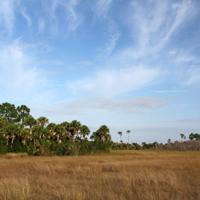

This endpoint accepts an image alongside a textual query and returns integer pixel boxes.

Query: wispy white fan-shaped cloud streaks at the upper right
[127,0,194,58]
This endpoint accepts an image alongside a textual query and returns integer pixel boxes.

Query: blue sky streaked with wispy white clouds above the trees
[0,0,200,142]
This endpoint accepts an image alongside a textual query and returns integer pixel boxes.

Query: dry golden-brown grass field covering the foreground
[0,151,200,200]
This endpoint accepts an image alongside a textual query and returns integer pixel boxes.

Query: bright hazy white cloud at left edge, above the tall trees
[0,41,52,104]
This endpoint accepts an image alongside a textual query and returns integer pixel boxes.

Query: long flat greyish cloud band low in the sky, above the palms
[47,97,167,116]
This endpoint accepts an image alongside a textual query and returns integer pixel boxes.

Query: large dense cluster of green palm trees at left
[0,103,112,155]
